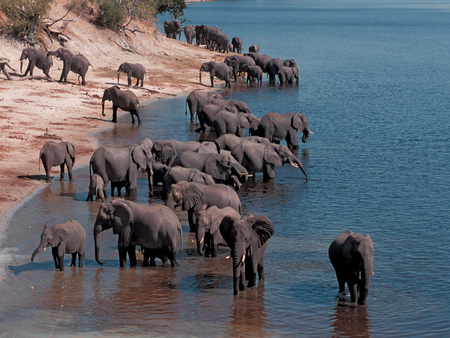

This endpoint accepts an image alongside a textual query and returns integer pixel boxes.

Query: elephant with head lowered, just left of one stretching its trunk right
[172,151,248,190]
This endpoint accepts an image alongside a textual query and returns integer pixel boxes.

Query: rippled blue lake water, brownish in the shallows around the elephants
[0,0,450,336]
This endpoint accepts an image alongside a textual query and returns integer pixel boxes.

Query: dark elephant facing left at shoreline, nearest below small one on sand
[102,86,141,124]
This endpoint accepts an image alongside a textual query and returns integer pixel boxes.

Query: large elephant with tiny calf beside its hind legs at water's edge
[89,138,153,197]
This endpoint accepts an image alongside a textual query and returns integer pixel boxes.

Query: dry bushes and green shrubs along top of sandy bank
[0,0,186,46]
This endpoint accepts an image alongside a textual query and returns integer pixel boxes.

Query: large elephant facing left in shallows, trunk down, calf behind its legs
[94,199,182,268]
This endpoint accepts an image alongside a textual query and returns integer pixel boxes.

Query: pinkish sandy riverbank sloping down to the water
[0,1,224,225]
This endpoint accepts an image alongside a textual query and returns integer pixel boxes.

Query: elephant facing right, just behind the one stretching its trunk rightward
[257,112,313,149]
